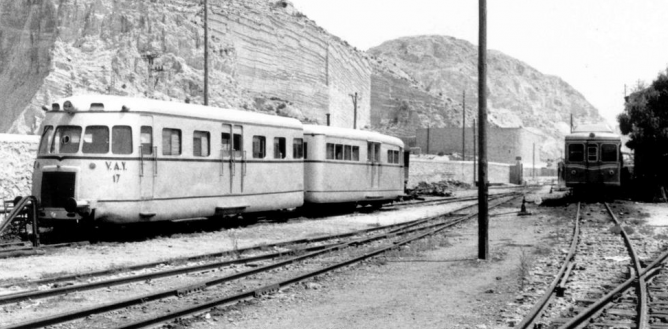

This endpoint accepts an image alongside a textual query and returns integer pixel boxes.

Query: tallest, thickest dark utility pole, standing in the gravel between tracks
[478,0,489,259]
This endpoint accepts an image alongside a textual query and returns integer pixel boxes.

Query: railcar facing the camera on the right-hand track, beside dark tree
[563,125,623,189]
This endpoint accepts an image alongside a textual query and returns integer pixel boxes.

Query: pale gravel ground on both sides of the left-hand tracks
[0,188,563,328]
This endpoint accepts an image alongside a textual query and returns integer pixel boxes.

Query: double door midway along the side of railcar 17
[221,124,247,194]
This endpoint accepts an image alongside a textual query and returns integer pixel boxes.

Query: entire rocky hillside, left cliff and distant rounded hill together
[0,0,600,158]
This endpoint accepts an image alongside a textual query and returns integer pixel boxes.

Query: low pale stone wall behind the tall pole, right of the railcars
[408,155,512,188]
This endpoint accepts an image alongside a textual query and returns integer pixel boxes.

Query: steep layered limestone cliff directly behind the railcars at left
[0,0,371,134]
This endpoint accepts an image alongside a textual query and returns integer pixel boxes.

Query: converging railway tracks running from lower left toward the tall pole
[0,191,528,328]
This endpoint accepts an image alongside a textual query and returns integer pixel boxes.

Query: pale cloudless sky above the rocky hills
[291,0,668,125]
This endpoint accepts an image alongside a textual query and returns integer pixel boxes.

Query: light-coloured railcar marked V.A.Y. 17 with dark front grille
[33,95,304,223]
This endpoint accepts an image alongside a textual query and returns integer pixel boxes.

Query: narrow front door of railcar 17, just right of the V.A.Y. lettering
[139,115,158,212]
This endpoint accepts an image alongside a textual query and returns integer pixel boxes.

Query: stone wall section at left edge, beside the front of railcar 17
[0,134,39,200]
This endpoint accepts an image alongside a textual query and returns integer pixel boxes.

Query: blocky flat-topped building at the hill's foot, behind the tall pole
[416,127,543,165]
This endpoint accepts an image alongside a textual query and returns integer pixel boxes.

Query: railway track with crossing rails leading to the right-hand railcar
[517,203,668,329]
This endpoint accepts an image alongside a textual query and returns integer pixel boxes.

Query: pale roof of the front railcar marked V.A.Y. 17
[52,95,302,129]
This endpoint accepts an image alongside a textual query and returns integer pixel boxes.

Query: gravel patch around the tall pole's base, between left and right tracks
[179,190,548,328]
